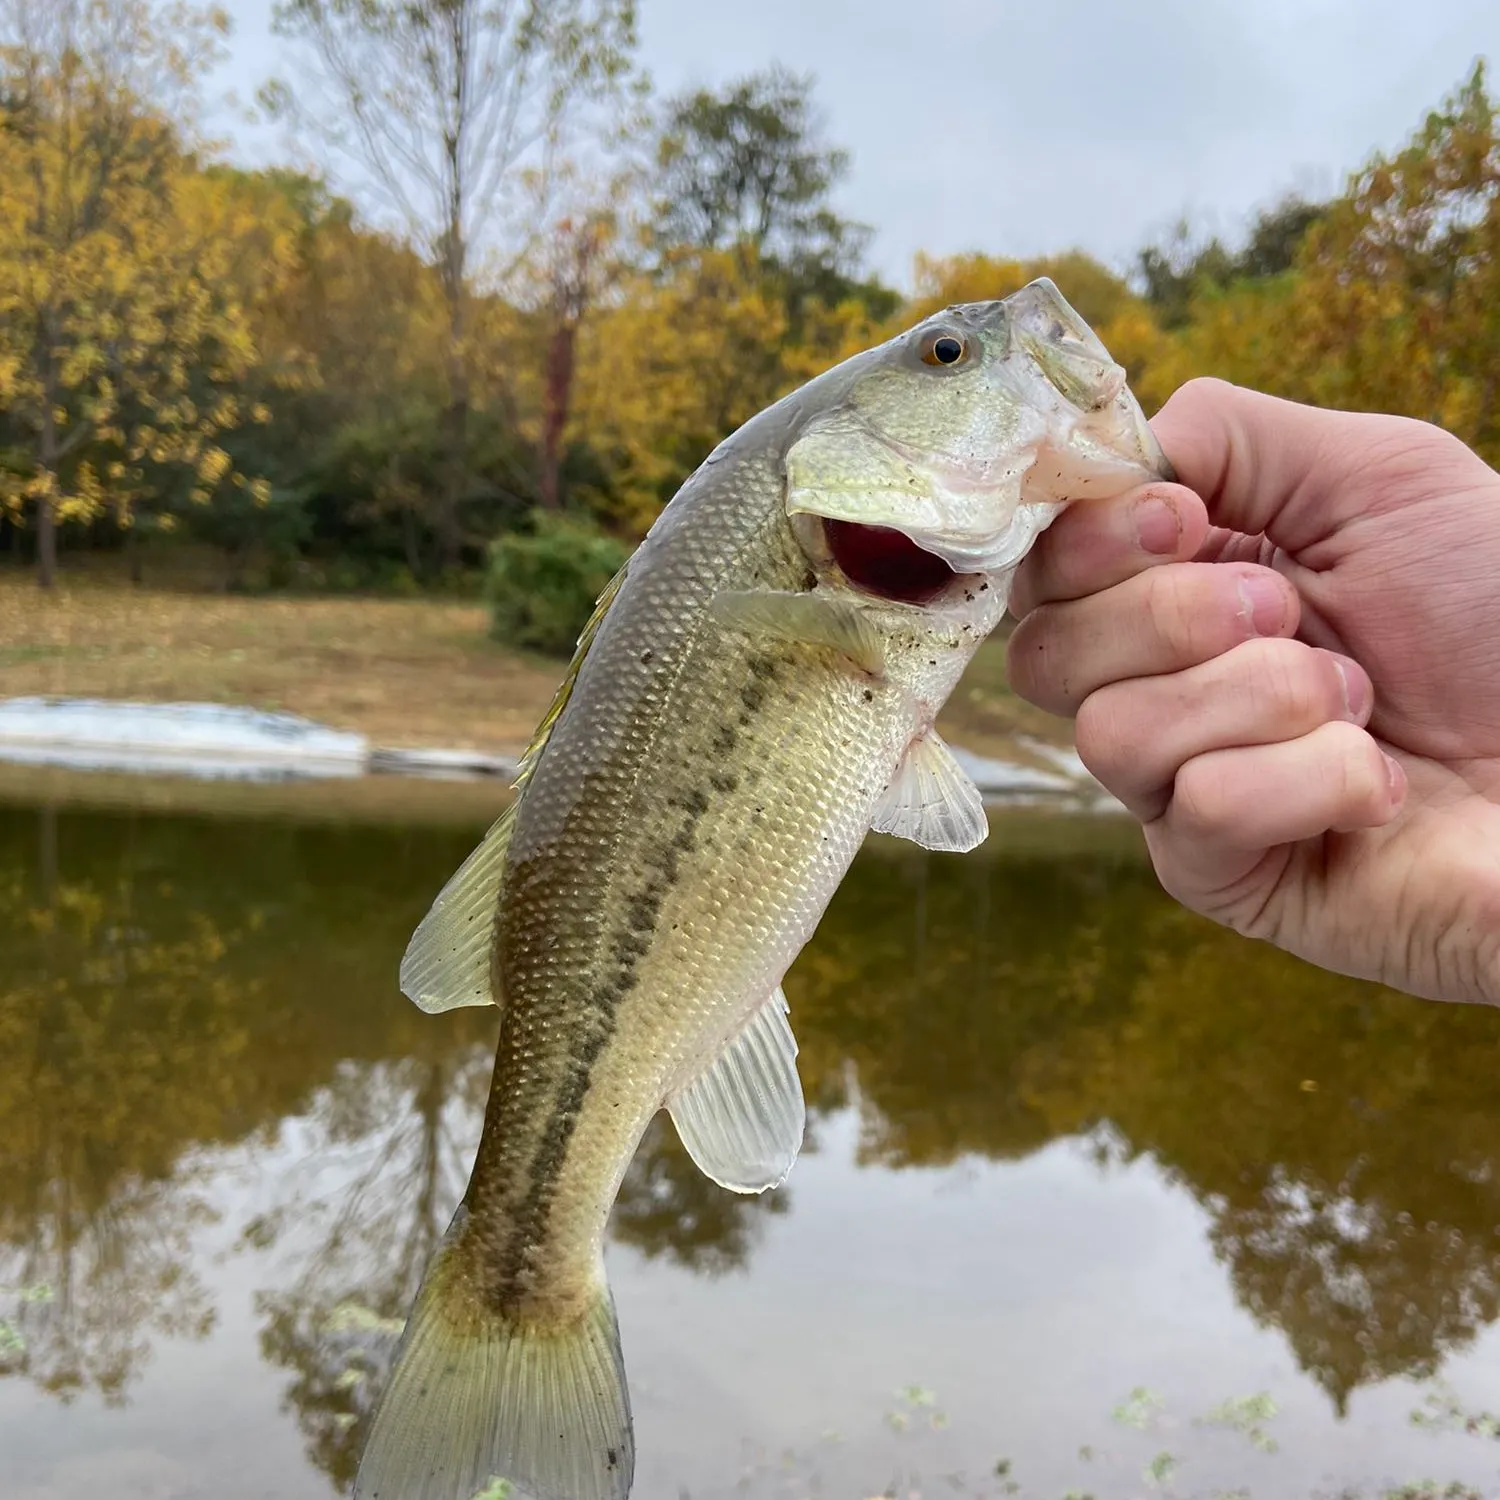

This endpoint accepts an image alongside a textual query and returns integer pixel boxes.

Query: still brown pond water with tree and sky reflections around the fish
[0,783,1500,1500]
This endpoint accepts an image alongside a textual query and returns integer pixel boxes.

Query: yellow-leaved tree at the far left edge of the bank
[0,0,289,587]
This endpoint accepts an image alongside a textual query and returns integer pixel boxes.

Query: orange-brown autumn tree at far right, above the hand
[1176,66,1500,462]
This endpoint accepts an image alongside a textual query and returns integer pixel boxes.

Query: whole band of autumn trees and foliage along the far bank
[11,19,1500,603]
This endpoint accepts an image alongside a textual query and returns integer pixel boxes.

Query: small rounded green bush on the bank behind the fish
[485,516,630,657]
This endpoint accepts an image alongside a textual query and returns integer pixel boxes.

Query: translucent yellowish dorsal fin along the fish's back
[401,563,630,1013]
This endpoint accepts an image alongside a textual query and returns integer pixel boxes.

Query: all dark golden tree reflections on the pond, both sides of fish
[0,809,1500,1484]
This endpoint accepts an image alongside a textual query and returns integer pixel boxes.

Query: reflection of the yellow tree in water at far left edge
[0,810,249,1406]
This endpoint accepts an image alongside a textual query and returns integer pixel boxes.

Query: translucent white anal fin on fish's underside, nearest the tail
[668,986,807,1193]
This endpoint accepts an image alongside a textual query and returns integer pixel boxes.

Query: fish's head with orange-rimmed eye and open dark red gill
[786,279,1170,602]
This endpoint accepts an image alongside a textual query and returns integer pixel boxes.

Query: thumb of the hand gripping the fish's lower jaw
[1151,380,1421,552]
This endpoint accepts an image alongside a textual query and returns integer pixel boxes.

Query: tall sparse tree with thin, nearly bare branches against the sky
[276,0,635,566]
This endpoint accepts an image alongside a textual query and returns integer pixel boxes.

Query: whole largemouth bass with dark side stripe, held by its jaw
[354,279,1170,1500]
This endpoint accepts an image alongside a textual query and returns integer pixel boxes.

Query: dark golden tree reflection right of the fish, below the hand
[788,855,1500,1412]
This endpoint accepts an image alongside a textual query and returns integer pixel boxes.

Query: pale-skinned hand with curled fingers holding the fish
[1010,380,1500,1004]
